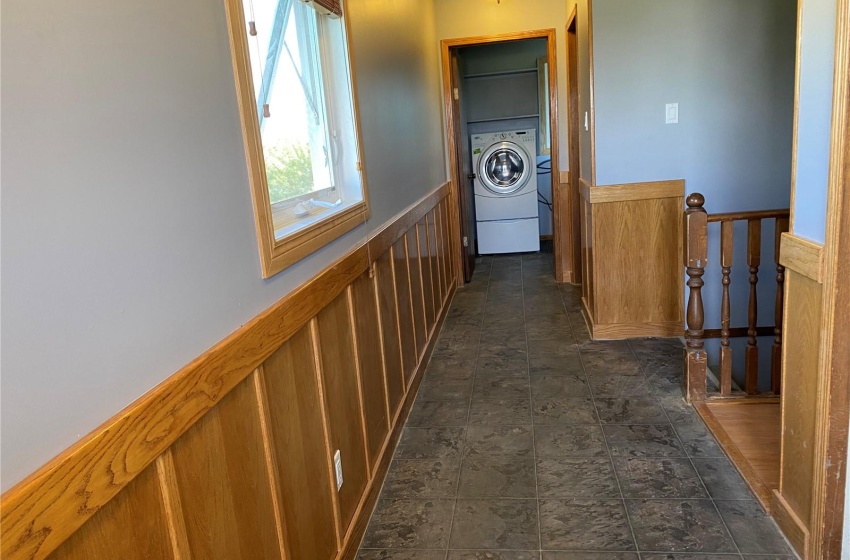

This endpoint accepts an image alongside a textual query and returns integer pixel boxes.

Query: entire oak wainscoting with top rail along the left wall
[0,184,457,560]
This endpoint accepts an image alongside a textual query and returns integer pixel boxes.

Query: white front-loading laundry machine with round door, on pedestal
[470,129,540,255]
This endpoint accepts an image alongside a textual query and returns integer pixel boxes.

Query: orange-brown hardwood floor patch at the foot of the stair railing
[699,399,781,509]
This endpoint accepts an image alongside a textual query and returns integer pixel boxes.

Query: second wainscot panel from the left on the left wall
[168,377,282,560]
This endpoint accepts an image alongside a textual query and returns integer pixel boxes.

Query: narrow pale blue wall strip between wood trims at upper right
[794,0,836,243]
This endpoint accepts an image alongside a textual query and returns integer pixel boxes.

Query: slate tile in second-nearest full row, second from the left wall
[458,455,537,498]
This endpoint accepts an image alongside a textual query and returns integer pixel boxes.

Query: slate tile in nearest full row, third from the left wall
[540,499,635,551]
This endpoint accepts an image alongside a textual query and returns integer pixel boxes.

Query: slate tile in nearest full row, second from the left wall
[449,499,540,550]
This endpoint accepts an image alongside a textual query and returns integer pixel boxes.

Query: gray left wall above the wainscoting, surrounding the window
[0,0,445,490]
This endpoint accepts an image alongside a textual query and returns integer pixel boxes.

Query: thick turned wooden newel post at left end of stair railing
[682,193,708,402]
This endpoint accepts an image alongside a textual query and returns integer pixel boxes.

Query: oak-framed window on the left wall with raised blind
[225,0,369,278]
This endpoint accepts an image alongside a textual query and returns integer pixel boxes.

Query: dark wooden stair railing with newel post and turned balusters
[683,193,790,402]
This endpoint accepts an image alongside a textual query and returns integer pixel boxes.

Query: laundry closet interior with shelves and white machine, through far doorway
[456,39,552,255]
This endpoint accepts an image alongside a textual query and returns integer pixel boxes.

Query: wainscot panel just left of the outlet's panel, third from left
[261,326,339,560]
